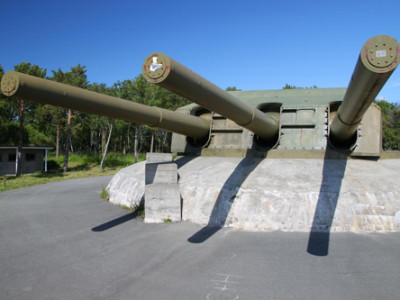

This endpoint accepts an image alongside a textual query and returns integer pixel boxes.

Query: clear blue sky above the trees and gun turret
[0,0,400,102]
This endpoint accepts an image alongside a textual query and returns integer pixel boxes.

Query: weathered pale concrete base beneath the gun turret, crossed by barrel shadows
[108,157,400,232]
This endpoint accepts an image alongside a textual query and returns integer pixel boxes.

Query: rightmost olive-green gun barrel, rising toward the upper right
[330,35,400,146]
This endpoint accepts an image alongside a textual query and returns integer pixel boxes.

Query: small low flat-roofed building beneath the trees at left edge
[0,146,53,176]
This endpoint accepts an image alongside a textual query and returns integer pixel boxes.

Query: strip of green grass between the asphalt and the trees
[0,153,145,192]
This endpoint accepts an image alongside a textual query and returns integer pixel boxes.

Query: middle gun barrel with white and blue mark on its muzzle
[142,52,279,139]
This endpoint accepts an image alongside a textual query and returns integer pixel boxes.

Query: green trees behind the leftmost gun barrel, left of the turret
[0,62,189,173]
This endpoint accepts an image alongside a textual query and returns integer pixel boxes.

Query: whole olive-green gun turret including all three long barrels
[1,35,400,157]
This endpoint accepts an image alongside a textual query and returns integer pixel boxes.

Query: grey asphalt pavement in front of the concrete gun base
[0,177,400,300]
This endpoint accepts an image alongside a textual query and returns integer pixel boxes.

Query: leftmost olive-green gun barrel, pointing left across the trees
[1,71,210,138]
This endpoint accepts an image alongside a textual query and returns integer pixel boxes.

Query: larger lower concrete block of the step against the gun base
[144,183,181,223]
